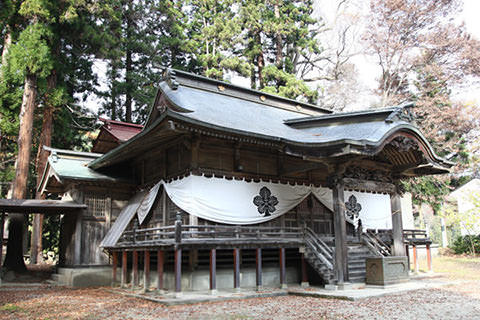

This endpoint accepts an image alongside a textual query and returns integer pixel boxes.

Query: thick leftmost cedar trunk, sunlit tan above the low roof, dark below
[4,73,37,271]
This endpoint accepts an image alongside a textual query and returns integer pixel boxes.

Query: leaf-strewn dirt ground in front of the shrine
[0,257,480,320]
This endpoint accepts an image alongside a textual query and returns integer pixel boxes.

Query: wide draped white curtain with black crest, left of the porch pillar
[163,175,333,225]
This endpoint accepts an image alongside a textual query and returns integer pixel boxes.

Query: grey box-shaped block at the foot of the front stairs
[366,256,408,286]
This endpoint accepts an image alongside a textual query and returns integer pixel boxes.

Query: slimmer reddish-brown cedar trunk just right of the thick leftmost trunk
[30,70,57,264]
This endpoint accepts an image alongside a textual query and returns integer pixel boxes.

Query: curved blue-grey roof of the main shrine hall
[89,72,452,173]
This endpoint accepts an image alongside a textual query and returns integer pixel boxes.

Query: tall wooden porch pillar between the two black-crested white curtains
[333,179,348,284]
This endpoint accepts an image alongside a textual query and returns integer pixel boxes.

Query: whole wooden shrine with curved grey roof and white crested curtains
[39,70,451,292]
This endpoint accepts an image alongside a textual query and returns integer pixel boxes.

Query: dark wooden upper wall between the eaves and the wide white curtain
[132,135,328,186]
